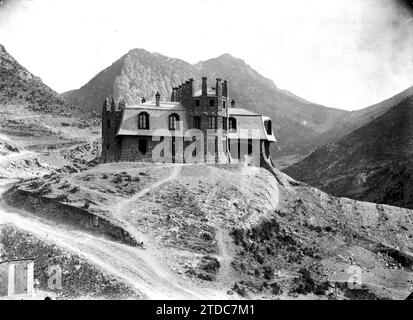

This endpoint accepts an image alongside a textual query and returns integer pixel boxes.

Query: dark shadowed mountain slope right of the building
[284,89,413,208]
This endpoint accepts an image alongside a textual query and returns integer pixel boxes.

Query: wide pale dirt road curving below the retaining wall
[0,180,214,299]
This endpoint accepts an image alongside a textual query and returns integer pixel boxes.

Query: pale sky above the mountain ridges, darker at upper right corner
[0,0,413,110]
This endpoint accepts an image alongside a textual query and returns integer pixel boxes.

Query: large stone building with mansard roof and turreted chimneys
[101,77,276,165]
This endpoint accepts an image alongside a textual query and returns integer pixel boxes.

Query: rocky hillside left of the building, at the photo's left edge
[0,45,100,179]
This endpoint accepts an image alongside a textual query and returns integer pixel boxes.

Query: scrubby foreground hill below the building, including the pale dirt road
[3,163,413,299]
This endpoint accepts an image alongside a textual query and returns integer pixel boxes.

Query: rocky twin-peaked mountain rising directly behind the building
[63,49,347,156]
